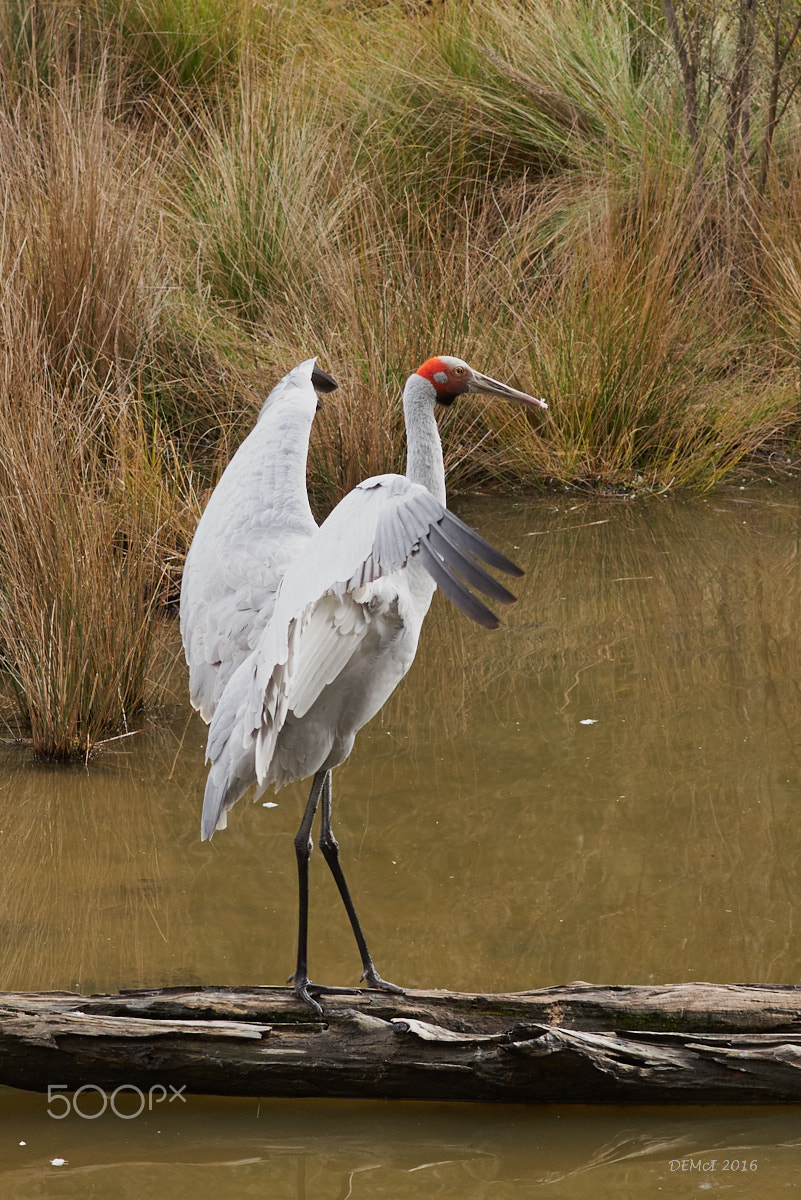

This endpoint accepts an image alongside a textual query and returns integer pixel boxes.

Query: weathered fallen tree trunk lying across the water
[0,983,801,1104]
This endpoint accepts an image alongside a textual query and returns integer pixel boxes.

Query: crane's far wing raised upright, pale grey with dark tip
[181,359,337,721]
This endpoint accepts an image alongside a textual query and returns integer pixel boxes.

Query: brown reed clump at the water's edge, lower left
[0,408,159,758]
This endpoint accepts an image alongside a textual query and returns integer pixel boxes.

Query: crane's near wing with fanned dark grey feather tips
[203,475,523,838]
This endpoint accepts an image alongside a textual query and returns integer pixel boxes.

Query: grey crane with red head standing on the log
[181,355,547,1013]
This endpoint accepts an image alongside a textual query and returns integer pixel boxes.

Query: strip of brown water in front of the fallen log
[0,1092,800,1200]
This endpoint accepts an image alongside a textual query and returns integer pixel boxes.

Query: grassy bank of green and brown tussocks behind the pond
[0,0,801,756]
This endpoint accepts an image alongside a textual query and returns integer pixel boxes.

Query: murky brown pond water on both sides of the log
[0,487,801,1200]
